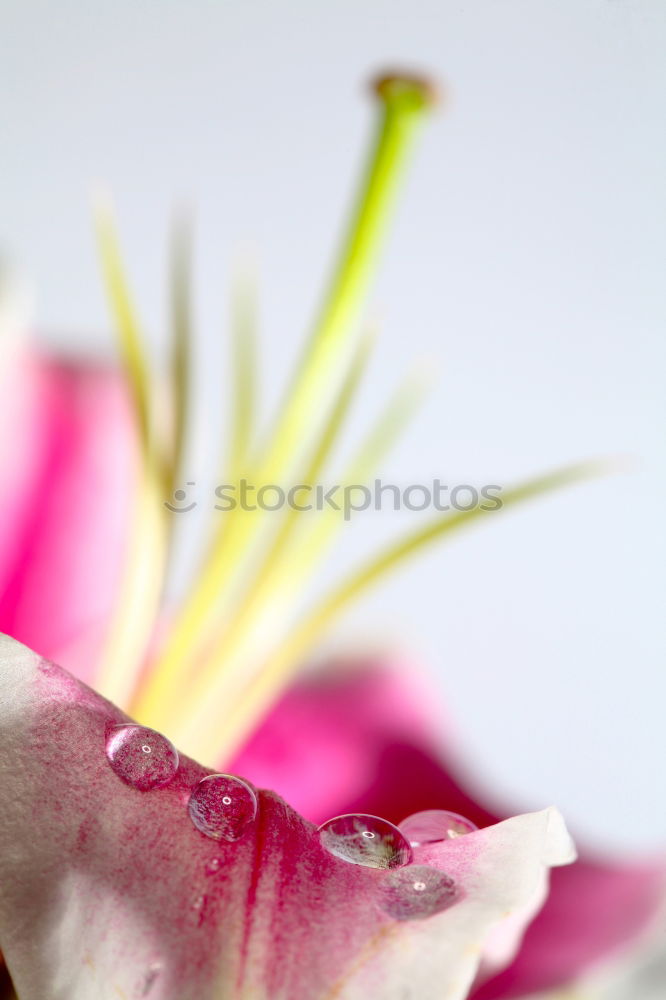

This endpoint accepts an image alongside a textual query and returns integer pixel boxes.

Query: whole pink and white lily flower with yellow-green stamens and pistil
[0,75,663,1000]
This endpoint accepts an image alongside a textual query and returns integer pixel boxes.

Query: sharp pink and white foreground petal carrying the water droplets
[0,638,571,1000]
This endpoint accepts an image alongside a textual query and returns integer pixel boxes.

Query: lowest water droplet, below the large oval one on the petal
[380,865,460,920]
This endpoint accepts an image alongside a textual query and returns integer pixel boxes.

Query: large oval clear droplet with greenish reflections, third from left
[318,813,412,868]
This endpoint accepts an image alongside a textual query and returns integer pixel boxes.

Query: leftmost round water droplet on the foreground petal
[106,724,178,792]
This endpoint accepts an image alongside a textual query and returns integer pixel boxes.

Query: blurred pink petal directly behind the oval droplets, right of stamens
[228,661,496,826]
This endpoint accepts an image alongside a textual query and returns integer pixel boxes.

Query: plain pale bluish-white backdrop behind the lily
[0,0,666,848]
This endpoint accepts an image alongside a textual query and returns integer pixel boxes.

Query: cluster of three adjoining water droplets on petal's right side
[317,809,477,921]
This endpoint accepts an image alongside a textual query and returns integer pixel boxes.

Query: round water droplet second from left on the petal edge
[188,774,257,841]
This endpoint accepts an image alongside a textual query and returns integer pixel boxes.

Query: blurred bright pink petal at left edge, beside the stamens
[0,348,136,679]
